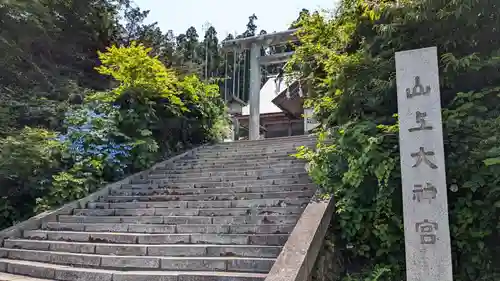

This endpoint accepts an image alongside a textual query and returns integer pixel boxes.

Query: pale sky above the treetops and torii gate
[134,0,336,39]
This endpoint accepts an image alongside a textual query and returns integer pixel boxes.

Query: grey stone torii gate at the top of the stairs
[222,29,298,140]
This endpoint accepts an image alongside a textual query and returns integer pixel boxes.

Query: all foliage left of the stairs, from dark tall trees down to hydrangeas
[0,0,238,228]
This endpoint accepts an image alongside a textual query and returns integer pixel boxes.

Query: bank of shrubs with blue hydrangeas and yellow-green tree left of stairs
[0,43,228,228]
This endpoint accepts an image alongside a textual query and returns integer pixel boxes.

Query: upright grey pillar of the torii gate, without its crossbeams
[248,43,261,140]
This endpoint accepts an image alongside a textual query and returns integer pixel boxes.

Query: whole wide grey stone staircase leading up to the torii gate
[0,136,315,281]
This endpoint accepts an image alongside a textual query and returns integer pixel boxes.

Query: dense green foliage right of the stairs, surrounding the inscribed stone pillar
[293,0,500,281]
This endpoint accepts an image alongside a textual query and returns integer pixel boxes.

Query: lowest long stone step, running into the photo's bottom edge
[0,259,266,281]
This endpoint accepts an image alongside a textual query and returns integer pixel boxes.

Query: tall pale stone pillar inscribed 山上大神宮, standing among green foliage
[396,47,453,281]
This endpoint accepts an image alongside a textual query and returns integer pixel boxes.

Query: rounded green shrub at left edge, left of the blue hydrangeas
[0,127,63,227]
